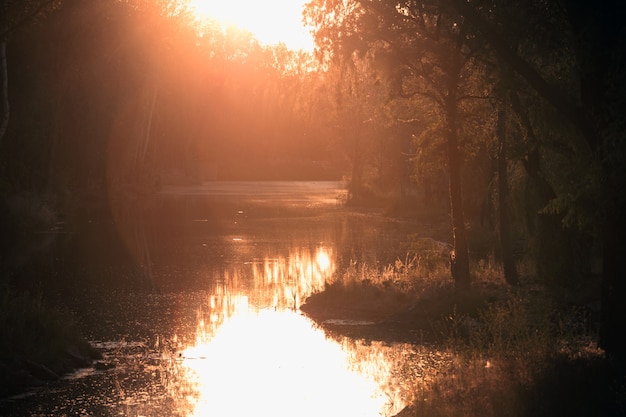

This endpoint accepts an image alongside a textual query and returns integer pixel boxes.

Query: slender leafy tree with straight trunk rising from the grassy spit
[309,0,500,288]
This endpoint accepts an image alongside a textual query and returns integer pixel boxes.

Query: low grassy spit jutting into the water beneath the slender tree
[300,272,510,343]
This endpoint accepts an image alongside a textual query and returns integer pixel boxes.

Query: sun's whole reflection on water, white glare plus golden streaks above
[169,246,403,417]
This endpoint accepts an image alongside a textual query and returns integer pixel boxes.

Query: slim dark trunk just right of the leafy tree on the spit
[496,110,519,285]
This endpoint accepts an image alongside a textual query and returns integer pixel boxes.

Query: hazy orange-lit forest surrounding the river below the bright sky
[0,0,626,412]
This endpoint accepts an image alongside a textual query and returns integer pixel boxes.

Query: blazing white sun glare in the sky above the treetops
[189,0,314,52]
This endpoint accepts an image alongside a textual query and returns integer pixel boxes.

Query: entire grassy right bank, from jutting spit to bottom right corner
[303,234,626,417]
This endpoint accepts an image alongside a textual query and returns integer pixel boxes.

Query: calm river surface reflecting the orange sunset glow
[0,182,442,417]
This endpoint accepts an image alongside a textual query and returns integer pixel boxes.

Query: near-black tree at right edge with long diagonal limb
[442,0,626,364]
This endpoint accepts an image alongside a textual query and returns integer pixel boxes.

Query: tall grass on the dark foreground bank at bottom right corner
[394,263,626,417]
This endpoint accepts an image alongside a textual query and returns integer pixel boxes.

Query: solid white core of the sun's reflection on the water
[183,310,398,417]
